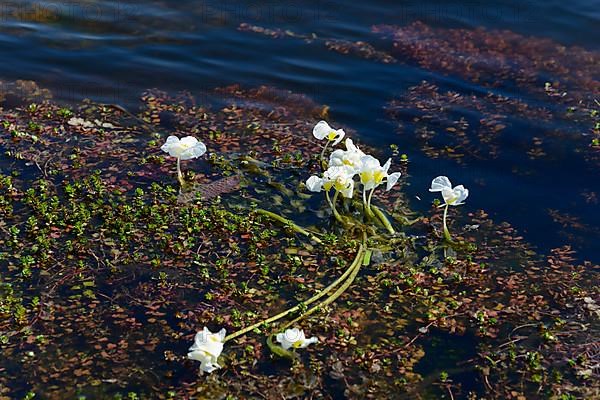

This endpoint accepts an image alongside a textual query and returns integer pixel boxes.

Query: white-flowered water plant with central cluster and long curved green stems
[190,121,408,373]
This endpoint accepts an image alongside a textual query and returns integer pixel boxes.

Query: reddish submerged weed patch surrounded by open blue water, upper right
[238,22,600,167]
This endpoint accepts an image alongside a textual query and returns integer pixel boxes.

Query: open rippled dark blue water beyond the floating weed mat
[0,0,600,261]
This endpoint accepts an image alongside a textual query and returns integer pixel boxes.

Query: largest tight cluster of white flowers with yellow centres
[306,121,400,202]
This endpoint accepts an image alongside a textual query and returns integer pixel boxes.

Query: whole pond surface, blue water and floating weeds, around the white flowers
[0,0,600,400]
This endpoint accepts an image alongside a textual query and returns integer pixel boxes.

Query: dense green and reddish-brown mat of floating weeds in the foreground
[0,80,600,399]
